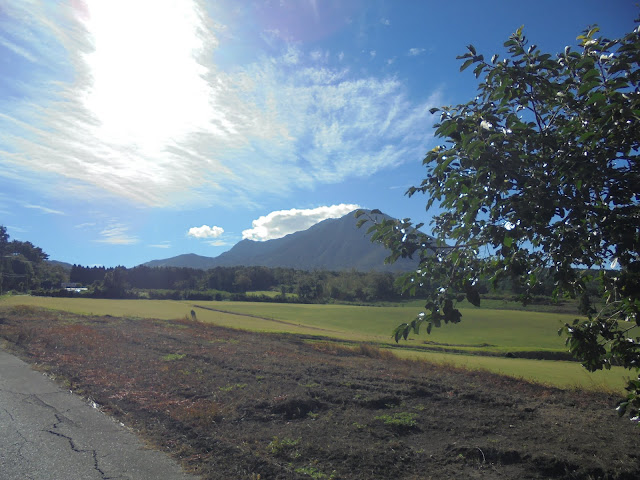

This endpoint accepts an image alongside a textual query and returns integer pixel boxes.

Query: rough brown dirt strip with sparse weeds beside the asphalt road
[0,307,640,480]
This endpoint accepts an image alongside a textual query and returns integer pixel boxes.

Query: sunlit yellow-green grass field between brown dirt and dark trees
[0,296,630,391]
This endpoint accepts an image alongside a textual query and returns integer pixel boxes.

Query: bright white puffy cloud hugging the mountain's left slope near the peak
[242,203,360,241]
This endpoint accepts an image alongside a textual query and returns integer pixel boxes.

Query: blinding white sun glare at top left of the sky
[80,0,213,151]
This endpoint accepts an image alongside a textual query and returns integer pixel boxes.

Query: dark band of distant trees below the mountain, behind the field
[70,265,402,302]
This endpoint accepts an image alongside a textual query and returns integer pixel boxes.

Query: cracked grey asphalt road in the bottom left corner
[0,349,198,480]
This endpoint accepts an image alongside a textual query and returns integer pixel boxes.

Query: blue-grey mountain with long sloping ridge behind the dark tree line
[143,212,417,272]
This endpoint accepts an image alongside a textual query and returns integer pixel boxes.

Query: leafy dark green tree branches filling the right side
[361,22,640,417]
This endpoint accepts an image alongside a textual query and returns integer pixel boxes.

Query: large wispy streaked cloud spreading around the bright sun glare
[0,0,439,207]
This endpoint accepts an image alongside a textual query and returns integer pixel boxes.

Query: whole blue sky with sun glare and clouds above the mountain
[0,0,640,266]
